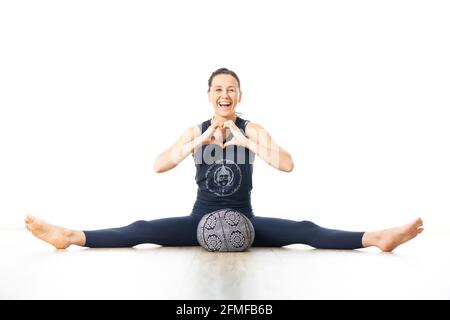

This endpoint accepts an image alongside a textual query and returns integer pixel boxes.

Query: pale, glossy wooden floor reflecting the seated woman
[0,229,450,299]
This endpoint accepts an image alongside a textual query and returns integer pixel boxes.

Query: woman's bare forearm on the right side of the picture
[246,139,294,172]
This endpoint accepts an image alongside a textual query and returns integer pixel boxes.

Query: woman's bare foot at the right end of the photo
[374,218,423,252]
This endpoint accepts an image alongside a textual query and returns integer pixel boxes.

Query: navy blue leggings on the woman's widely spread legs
[84,214,364,249]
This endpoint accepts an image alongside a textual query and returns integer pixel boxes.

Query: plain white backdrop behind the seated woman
[0,0,450,230]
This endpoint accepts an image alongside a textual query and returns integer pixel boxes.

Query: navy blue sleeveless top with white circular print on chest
[192,117,255,217]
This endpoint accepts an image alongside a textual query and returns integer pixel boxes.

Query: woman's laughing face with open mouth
[208,74,241,118]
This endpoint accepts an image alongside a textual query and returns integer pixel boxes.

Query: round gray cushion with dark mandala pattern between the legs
[197,209,255,252]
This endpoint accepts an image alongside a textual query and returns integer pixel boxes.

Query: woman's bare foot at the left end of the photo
[25,214,71,249]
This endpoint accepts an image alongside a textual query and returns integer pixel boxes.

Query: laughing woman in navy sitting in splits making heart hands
[25,68,423,251]
